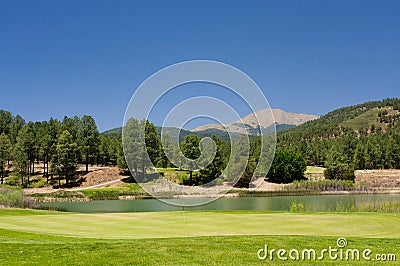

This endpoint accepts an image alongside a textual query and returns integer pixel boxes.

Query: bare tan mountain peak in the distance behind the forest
[190,109,319,135]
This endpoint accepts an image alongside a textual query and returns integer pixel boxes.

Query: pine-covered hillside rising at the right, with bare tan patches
[278,98,400,170]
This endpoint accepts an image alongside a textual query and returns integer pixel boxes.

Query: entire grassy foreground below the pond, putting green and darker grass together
[0,210,400,265]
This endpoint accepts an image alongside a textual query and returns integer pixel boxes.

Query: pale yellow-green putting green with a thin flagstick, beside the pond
[0,210,400,239]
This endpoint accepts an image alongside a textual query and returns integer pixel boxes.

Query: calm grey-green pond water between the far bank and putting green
[42,194,400,213]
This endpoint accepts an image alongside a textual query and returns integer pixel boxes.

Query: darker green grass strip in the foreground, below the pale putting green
[0,230,400,265]
